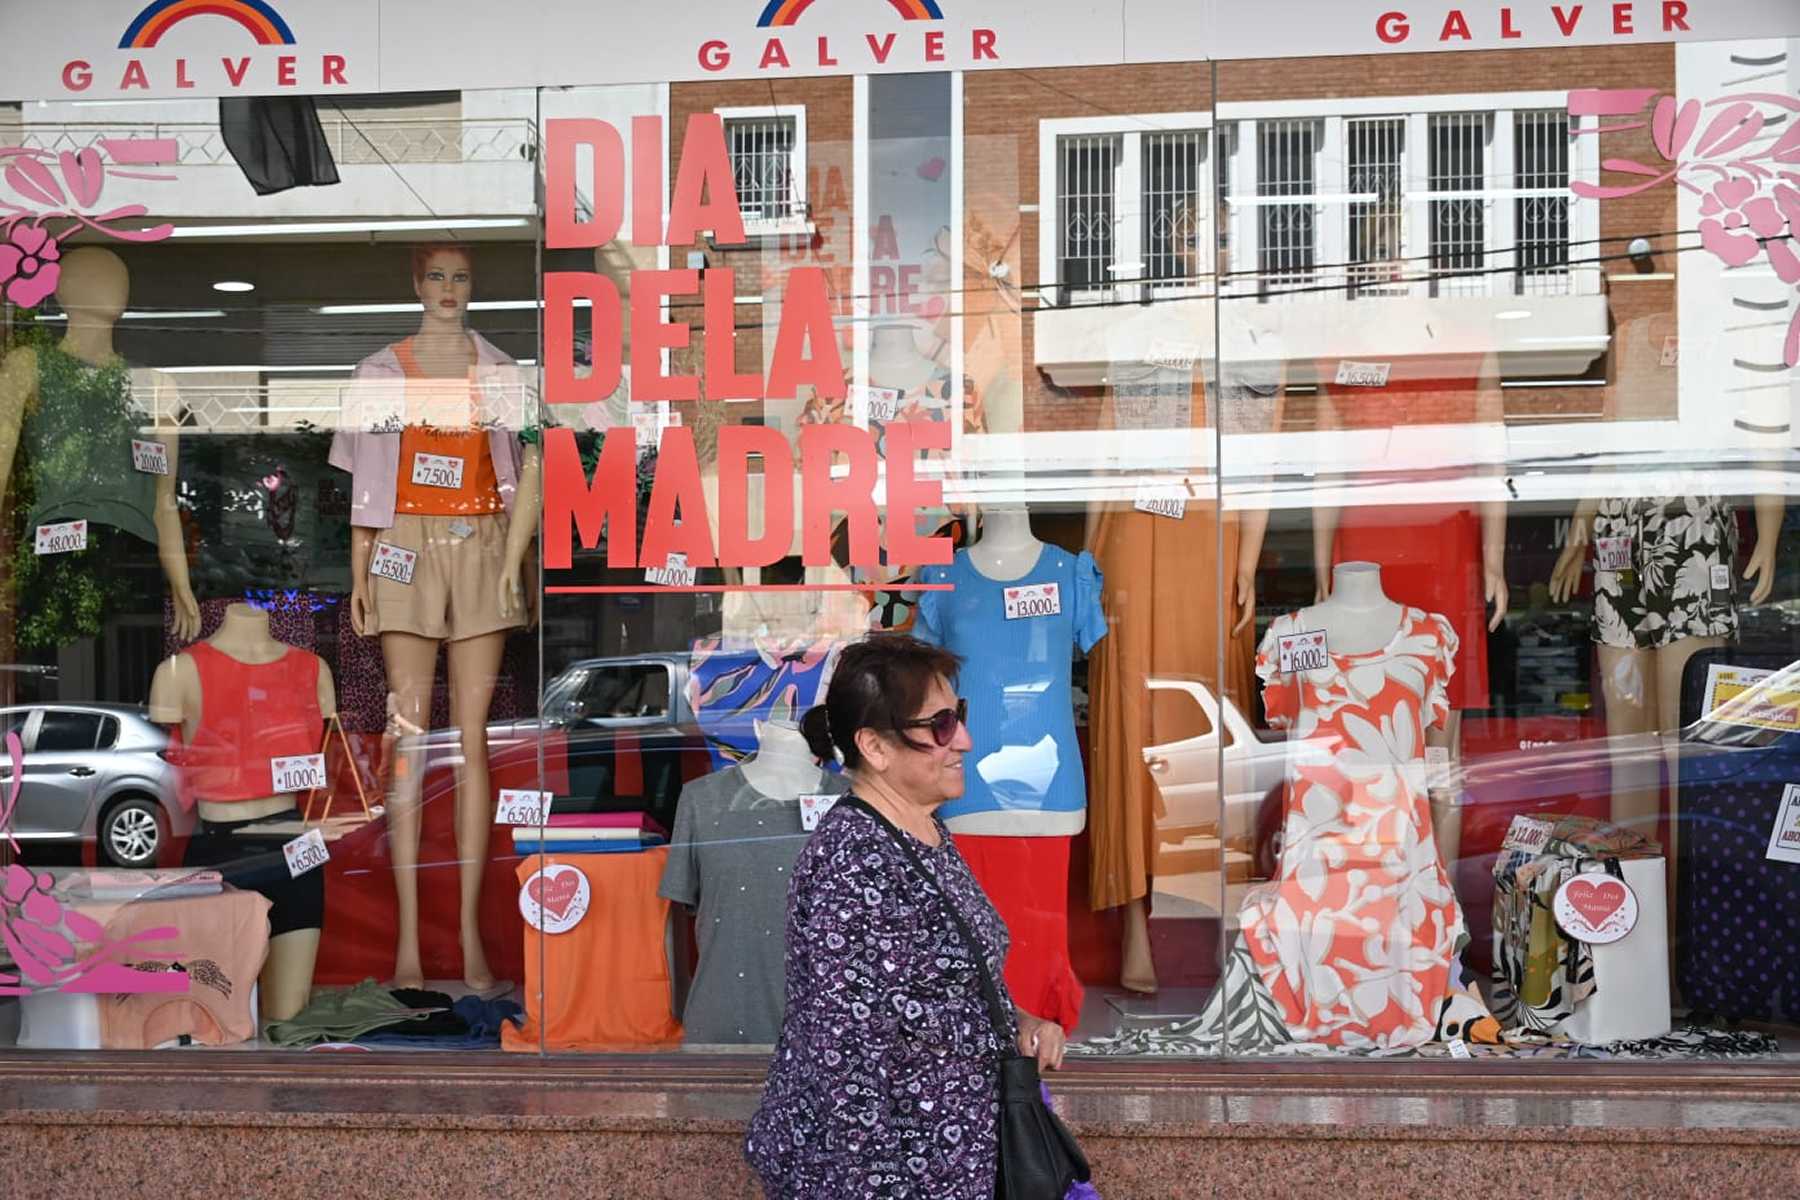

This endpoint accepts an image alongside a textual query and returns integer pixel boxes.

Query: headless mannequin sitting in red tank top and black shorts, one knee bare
[149,604,337,1020]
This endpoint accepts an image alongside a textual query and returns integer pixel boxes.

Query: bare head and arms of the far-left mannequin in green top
[0,246,200,642]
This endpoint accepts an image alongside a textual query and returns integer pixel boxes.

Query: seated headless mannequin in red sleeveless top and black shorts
[149,604,337,1020]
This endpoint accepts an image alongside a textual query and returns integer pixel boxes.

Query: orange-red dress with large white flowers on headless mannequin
[1240,608,1465,1049]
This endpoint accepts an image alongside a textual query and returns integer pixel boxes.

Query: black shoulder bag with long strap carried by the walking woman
[841,795,1089,1200]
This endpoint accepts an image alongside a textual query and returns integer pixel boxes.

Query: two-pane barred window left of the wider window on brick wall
[1055,128,1213,304]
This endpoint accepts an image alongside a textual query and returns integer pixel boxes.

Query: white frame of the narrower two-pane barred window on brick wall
[1037,112,1219,308]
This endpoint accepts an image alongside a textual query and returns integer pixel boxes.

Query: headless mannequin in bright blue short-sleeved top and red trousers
[914,504,1107,1029]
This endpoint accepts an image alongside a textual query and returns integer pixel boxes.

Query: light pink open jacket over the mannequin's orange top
[331,331,529,529]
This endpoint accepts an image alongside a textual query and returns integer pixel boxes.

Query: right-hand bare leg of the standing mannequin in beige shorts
[450,633,506,991]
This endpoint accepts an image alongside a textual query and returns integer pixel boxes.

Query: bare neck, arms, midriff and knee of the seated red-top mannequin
[149,604,337,1020]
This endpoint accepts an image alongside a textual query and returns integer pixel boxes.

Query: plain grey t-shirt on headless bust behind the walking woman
[657,766,850,1045]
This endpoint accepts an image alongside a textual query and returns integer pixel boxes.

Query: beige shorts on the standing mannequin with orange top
[369,513,526,642]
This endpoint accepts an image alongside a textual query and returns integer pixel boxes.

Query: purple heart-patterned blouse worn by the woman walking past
[743,802,1012,1200]
